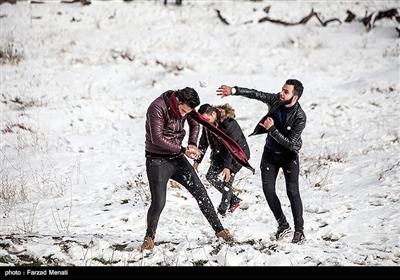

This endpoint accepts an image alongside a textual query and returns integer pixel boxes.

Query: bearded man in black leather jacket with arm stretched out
[217,79,307,244]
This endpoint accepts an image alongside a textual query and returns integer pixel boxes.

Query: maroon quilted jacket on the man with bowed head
[145,90,200,156]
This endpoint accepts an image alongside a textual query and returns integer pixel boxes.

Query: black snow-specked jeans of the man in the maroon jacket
[146,155,224,239]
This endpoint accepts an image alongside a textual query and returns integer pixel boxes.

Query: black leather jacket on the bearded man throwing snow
[233,87,307,153]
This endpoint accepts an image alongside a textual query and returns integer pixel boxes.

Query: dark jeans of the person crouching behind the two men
[206,160,241,213]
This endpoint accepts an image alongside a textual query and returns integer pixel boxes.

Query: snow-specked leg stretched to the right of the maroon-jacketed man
[171,157,224,233]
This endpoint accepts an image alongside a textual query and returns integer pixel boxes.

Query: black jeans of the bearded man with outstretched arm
[260,146,304,231]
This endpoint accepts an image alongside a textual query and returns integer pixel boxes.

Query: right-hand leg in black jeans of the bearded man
[283,155,304,231]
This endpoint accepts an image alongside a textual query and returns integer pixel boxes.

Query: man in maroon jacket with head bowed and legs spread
[141,87,233,251]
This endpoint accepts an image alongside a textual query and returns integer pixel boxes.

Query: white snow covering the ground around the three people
[0,0,400,269]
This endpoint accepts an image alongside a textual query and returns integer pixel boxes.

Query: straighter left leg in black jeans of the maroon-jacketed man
[146,158,174,239]
